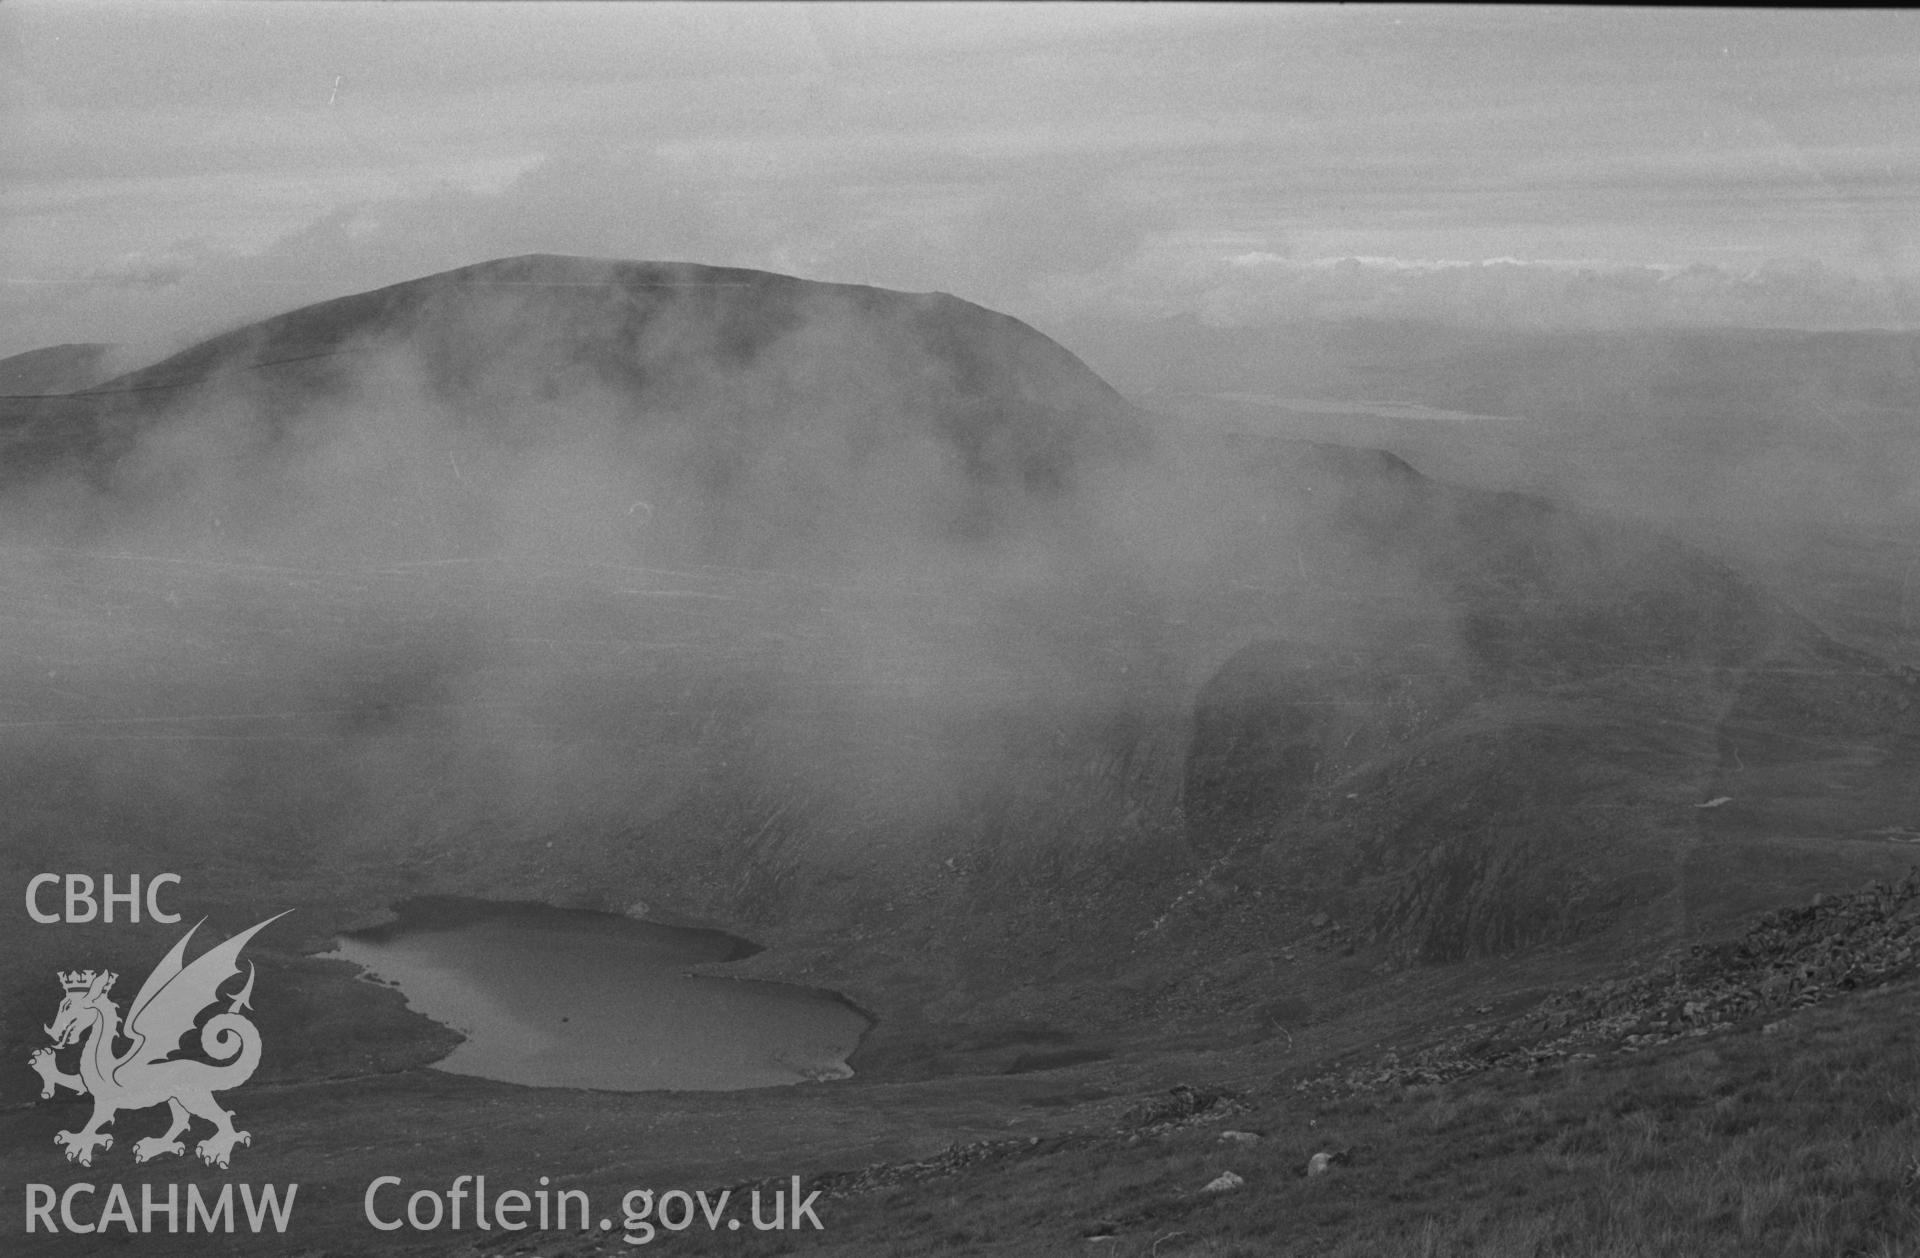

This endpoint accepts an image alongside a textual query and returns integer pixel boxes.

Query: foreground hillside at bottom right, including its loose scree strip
[633,872,1920,1258]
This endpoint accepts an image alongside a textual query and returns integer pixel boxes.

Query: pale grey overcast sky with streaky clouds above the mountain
[0,0,1920,353]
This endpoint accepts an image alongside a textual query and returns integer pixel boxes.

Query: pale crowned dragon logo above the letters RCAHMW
[27,908,292,1170]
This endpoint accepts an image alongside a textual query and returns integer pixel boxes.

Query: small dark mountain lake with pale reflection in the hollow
[328,897,868,1091]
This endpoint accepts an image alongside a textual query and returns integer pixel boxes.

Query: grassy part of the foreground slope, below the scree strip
[771,981,1920,1258]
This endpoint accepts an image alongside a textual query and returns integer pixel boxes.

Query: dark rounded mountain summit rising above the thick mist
[6,255,1140,563]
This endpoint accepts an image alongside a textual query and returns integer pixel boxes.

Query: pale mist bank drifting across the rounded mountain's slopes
[0,263,1450,933]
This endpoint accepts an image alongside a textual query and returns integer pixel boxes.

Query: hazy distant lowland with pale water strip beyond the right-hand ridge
[1113,319,1920,663]
